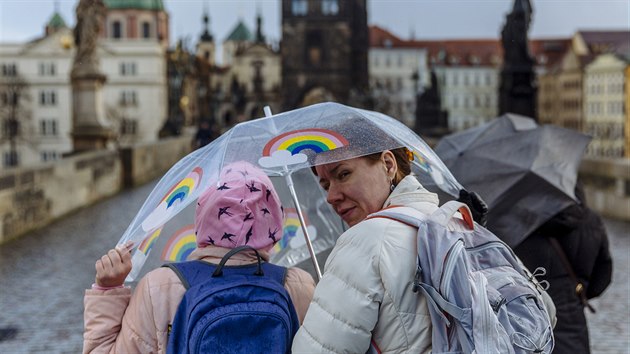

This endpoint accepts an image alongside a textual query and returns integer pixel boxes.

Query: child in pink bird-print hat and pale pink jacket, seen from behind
[83,162,315,353]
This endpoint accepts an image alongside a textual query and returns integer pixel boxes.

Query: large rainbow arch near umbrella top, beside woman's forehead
[263,128,348,156]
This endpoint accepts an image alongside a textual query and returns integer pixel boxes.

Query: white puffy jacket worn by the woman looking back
[292,176,438,353]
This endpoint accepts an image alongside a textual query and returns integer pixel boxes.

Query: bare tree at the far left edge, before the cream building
[0,73,35,166]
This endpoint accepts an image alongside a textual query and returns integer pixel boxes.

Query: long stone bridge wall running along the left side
[0,136,191,243]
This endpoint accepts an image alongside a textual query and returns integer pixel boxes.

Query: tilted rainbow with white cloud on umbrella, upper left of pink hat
[142,167,203,231]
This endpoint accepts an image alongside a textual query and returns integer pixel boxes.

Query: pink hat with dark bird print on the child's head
[195,161,284,251]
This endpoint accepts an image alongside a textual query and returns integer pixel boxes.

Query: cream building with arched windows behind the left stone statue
[0,0,168,166]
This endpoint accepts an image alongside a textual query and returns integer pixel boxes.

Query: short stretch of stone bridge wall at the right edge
[580,158,630,221]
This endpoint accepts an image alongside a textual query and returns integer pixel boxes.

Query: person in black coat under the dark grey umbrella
[514,188,612,354]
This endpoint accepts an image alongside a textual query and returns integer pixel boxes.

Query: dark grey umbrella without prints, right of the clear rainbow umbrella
[435,114,591,247]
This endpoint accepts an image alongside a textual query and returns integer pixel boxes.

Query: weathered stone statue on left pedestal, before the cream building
[72,0,105,76]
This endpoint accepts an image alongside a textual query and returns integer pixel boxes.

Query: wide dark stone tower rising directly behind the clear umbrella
[280,0,369,110]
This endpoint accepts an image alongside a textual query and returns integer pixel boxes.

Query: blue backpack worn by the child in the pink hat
[165,246,300,354]
